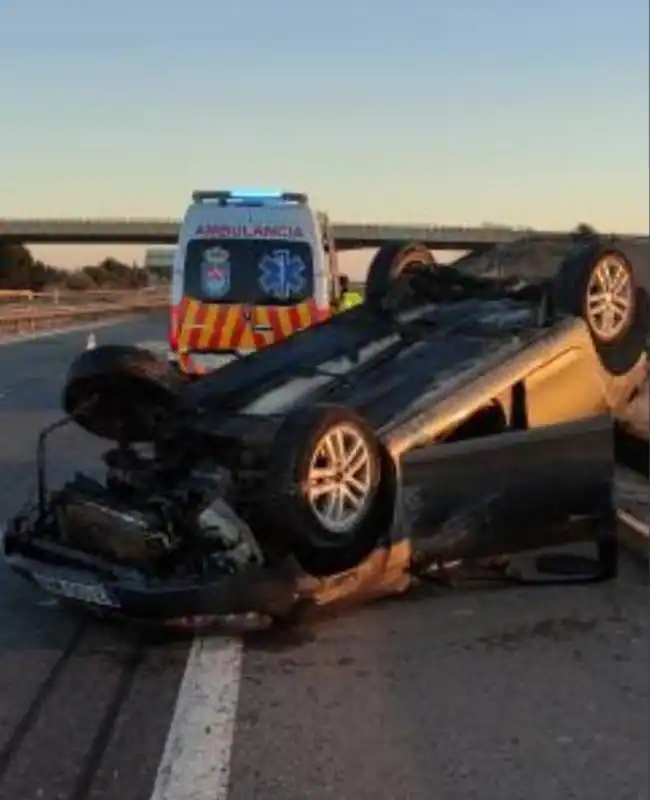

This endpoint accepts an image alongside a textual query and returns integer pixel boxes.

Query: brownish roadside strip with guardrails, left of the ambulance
[0,290,169,337]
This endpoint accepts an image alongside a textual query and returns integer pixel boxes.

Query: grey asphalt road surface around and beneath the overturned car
[0,321,649,800]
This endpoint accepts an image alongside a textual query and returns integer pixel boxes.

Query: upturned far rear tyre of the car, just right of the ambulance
[365,242,436,309]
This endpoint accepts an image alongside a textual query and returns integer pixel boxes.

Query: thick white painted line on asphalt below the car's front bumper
[151,636,242,800]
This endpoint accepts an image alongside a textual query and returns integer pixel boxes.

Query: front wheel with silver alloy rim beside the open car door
[265,405,388,575]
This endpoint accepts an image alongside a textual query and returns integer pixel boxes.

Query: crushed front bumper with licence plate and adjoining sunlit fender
[2,510,411,624]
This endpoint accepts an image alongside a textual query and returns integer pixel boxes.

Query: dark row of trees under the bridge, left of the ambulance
[0,241,169,292]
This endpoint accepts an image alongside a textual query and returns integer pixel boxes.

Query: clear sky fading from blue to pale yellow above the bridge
[0,0,649,266]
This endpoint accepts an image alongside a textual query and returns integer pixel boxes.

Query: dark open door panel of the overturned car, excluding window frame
[400,416,614,559]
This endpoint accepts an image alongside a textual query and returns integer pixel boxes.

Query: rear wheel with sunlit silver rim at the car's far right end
[553,241,649,375]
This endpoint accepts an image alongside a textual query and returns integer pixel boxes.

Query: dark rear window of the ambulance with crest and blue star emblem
[184,239,314,305]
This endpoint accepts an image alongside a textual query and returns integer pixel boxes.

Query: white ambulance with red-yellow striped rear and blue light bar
[169,190,339,376]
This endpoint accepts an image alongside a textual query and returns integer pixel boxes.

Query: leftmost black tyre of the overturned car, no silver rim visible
[63,345,185,444]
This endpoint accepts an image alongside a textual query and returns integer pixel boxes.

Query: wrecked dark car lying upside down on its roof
[3,241,648,622]
